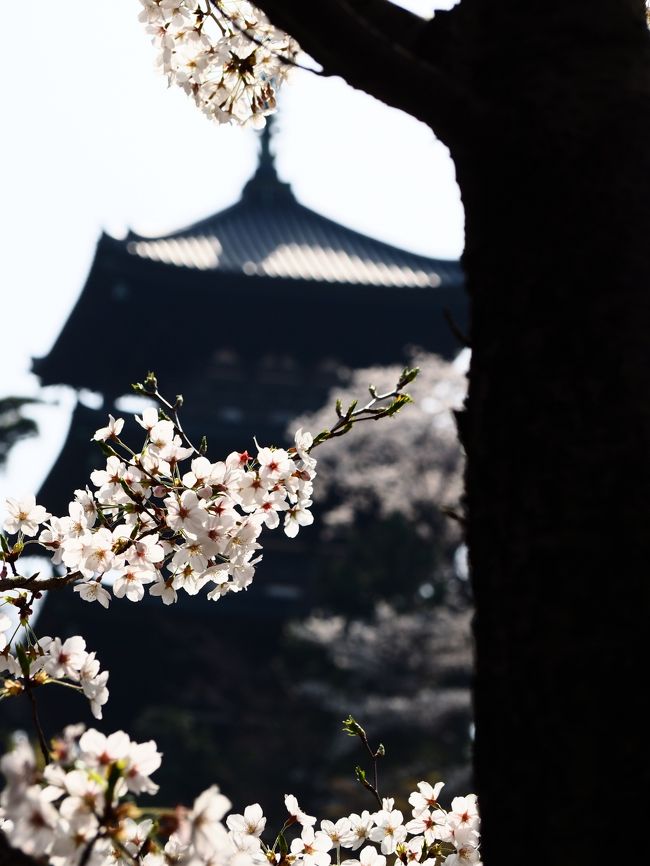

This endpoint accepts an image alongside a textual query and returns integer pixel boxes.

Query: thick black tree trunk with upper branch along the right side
[262,0,650,866]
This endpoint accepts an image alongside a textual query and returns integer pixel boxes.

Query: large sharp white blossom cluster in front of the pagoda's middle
[3,408,316,607]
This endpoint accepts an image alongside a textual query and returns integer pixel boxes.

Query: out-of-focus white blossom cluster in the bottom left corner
[0,725,161,866]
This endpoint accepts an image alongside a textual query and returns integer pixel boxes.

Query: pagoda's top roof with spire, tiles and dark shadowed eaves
[32,125,467,397]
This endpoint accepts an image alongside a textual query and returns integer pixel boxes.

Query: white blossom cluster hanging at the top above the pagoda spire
[139,0,299,128]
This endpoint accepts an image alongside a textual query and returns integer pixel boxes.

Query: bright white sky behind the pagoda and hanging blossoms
[0,0,463,502]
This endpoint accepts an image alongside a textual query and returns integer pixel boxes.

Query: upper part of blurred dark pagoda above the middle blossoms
[33,132,465,514]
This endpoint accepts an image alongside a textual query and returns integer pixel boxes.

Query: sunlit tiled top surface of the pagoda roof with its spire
[123,127,462,288]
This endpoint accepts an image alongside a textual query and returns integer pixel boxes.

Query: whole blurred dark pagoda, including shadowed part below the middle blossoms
[19,125,466,805]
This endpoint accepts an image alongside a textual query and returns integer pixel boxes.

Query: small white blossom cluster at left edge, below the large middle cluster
[0,632,108,719]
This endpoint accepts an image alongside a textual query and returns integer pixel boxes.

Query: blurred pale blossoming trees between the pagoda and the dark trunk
[286,355,472,806]
